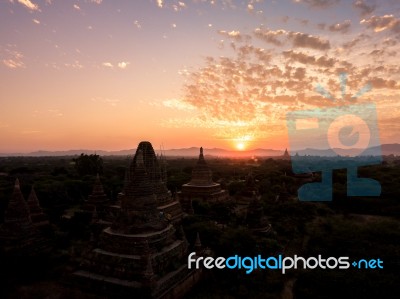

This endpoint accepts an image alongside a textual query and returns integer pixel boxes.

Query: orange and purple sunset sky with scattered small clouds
[0,0,400,153]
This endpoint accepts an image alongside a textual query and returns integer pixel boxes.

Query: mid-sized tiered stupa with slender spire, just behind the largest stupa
[178,147,228,213]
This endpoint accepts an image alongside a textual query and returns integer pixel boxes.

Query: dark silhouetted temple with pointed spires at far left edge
[0,179,50,257]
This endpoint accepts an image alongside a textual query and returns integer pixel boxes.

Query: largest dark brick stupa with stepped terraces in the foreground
[75,148,200,298]
